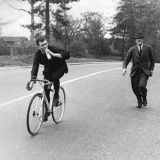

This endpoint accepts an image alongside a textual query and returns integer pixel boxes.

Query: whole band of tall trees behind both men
[0,0,160,62]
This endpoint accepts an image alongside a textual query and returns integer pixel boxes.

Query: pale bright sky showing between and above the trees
[0,0,118,38]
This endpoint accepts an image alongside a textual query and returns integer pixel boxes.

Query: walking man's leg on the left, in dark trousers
[131,75,142,108]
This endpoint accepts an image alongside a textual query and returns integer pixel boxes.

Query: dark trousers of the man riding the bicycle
[44,69,64,101]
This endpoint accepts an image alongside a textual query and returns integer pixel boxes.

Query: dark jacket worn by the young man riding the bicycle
[31,46,70,78]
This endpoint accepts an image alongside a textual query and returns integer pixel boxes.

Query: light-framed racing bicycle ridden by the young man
[27,79,66,135]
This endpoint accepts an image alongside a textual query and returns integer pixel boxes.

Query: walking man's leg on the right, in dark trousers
[139,73,149,106]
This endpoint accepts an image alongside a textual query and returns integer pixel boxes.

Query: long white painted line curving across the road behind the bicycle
[0,67,122,107]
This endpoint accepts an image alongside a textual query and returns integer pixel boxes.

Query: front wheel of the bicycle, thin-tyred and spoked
[27,93,44,135]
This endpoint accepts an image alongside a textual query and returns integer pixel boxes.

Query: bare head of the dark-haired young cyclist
[36,37,48,53]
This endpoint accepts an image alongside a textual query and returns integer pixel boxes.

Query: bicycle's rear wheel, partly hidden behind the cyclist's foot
[52,87,66,123]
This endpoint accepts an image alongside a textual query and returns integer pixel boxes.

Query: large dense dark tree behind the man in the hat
[110,0,160,62]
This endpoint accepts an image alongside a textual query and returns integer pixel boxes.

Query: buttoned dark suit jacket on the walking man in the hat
[123,44,155,77]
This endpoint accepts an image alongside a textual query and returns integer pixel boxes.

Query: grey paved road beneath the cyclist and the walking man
[0,63,160,160]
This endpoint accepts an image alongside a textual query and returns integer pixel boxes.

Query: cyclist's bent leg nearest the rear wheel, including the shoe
[52,69,64,105]
